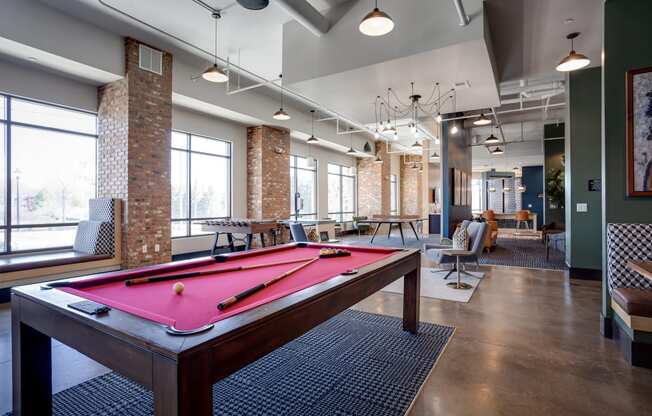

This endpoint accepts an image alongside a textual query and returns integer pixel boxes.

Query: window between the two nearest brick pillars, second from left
[171,131,231,237]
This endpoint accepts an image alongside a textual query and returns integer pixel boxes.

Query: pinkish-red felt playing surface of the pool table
[61,244,398,330]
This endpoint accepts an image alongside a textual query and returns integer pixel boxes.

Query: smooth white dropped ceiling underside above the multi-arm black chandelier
[289,40,499,123]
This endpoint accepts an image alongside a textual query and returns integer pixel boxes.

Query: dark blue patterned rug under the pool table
[7,310,454,416]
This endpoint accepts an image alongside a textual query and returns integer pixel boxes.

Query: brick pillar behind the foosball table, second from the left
[247,126,290,220]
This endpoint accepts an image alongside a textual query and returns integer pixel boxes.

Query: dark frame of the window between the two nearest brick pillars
[170,129,233,240]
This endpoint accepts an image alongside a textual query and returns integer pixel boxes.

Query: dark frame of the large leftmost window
[0,93,98,255]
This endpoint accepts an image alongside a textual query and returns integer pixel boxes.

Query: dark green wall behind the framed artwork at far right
[602,0,652,316]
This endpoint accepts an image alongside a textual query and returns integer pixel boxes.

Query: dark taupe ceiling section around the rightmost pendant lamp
[486,0,603,81]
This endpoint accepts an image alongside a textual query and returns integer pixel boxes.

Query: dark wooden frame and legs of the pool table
[11,243,421,416]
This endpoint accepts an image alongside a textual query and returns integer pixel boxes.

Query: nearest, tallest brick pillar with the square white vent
[97,38,172,268]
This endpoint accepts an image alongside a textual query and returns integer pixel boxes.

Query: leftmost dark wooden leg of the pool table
[11,299,52,416]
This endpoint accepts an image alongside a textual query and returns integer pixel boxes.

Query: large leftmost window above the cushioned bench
[0,95,97,253]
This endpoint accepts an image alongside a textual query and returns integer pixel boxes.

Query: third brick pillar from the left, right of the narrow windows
[358,142,391,217]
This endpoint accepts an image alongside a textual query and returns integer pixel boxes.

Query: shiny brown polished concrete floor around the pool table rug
[0,259,652,416]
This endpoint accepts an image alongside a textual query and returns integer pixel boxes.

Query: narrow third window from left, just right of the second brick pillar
[290,156,317,220]
